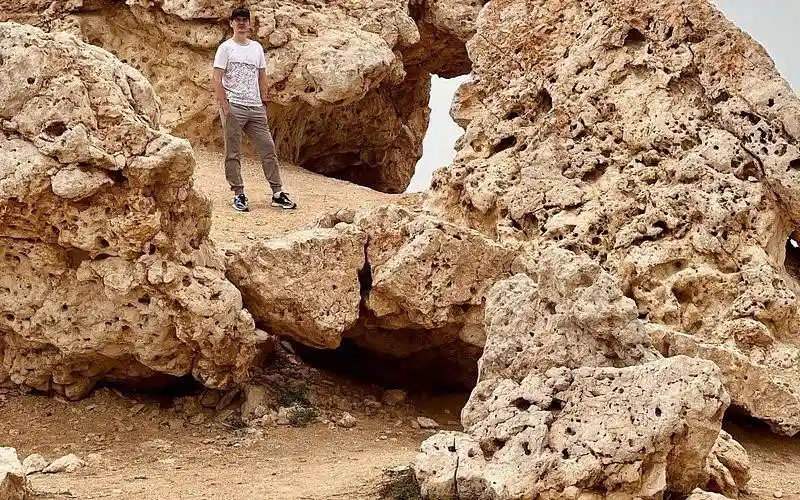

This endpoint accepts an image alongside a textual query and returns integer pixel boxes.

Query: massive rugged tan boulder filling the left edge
[0,23,258,398]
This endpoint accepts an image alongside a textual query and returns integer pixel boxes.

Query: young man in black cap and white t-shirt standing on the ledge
[213,7,297,212]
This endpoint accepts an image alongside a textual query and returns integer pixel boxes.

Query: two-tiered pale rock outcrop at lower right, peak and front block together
[415,249,735,499]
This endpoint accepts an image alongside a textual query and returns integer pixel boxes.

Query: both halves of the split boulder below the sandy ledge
[228,206,513,380]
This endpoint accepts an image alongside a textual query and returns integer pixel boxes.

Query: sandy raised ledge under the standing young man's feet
[194,149,419,249]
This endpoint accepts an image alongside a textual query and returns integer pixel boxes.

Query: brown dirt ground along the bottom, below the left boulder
[0,389,460,500]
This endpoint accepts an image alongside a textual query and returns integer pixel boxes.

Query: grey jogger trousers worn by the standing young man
[220,104,282,194]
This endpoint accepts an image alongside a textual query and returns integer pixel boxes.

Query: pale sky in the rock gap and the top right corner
[407,0,800,192]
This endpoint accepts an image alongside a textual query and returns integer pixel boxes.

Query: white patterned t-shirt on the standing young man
[214,38,267,106]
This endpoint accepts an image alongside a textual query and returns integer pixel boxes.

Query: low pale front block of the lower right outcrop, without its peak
[415,357,728,499]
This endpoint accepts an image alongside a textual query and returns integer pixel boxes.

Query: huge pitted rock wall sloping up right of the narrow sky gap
[428,0,800,435]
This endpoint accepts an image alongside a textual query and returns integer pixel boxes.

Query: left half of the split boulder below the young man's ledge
[228,229,366,348]
